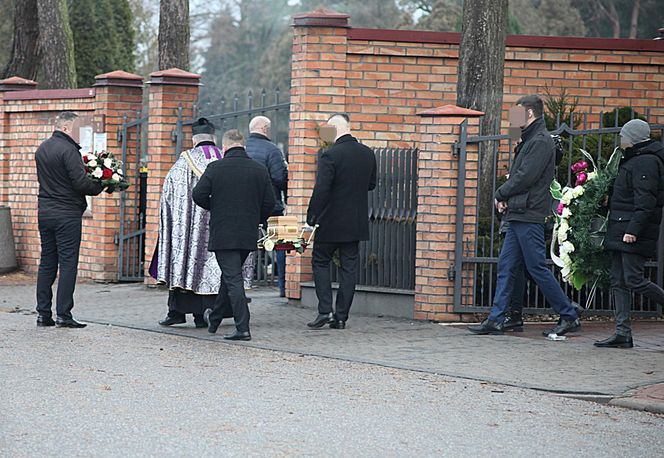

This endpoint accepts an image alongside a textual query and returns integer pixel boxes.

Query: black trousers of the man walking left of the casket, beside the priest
[210,250,251,332]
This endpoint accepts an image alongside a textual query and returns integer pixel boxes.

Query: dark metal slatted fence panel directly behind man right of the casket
[331,148,417,290]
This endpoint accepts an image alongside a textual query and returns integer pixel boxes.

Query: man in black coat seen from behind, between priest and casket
[193,129,275,340]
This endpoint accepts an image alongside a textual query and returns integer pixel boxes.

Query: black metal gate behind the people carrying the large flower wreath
[449,110,664,316]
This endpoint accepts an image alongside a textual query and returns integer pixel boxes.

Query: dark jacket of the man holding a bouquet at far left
[35,130,104,218]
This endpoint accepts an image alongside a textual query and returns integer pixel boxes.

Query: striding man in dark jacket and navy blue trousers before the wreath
[468,95,579,335]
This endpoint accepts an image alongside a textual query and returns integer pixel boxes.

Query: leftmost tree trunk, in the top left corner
[3,0,39,80]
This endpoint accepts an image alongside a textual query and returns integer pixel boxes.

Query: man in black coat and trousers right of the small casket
[307,114,376,329]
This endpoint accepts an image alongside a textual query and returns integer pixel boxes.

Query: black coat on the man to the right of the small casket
[307,135,376,243]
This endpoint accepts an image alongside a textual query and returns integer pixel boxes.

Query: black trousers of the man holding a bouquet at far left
[37,217,82,318]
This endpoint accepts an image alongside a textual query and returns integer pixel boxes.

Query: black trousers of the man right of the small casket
[312,242,359,321]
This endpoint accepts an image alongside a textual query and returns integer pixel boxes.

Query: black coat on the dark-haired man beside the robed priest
[193,147,274,251]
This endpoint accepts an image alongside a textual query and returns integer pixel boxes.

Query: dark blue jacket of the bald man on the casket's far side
[245,133,288,216]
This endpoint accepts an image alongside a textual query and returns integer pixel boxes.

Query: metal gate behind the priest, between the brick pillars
[173,89,290,286]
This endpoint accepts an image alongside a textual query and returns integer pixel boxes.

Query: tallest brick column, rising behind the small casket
[286,9,349,299]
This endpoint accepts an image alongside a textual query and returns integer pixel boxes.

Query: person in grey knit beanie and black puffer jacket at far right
[595,119,664,348]
